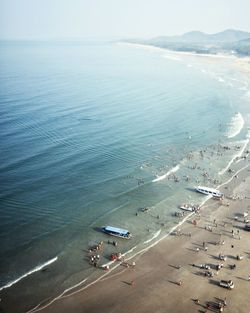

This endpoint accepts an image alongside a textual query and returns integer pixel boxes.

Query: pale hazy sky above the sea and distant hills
[0,0,250,39]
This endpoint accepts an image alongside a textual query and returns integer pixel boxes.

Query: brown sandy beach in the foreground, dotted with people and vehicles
[20,162,250,313]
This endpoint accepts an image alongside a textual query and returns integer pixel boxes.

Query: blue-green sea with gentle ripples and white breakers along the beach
[0,41,250,309]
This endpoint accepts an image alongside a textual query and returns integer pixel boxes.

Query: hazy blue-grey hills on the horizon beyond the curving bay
[129,29,250,55]
